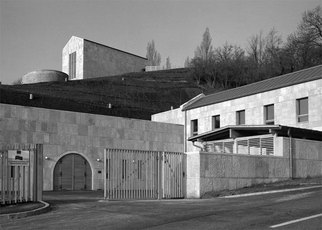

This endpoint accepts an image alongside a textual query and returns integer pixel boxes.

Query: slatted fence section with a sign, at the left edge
[0,145,42,205]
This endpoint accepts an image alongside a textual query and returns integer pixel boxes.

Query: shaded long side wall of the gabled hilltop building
[84,40,146,78]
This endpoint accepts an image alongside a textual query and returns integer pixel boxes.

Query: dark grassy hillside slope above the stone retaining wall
[0,69,201,120]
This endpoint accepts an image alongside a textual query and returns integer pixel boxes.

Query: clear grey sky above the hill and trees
[0,0,322,84]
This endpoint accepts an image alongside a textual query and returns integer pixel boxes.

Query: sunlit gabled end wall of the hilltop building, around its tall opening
[62,36,84,80]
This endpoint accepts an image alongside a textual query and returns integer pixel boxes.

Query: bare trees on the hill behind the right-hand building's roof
[185,6,322,89]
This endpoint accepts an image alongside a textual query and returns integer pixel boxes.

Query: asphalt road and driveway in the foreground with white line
[0,188,322,230]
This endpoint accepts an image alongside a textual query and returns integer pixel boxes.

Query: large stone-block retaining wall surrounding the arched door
[0,104,183,190]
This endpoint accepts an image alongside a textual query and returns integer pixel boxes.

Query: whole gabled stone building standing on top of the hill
[62,36,147,80]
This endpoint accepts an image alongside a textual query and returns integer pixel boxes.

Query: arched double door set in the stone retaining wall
[54,153,92,190]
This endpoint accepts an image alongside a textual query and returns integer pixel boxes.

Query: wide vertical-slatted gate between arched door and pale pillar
[104,149,183,200]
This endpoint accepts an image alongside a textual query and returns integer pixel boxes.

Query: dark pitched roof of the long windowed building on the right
[182,65,322,110]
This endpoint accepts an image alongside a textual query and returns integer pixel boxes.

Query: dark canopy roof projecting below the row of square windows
[188,125,322,142]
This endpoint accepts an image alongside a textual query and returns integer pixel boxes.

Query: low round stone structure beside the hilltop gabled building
[22,70,68,84]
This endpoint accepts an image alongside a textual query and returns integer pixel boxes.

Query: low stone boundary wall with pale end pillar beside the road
[186,137,322,198]
